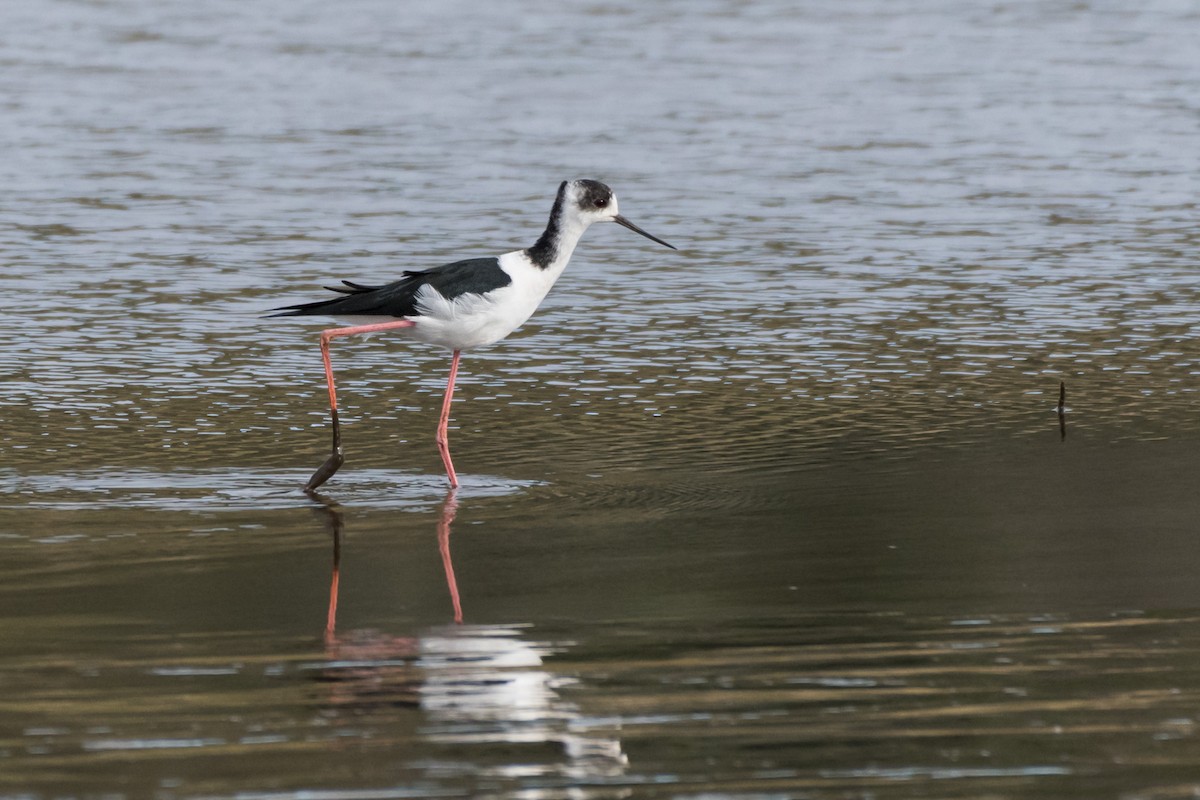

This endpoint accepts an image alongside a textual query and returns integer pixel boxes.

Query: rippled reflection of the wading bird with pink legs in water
[302,489,629,782]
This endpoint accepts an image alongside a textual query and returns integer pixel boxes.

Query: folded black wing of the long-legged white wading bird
[269,258,512,317]
